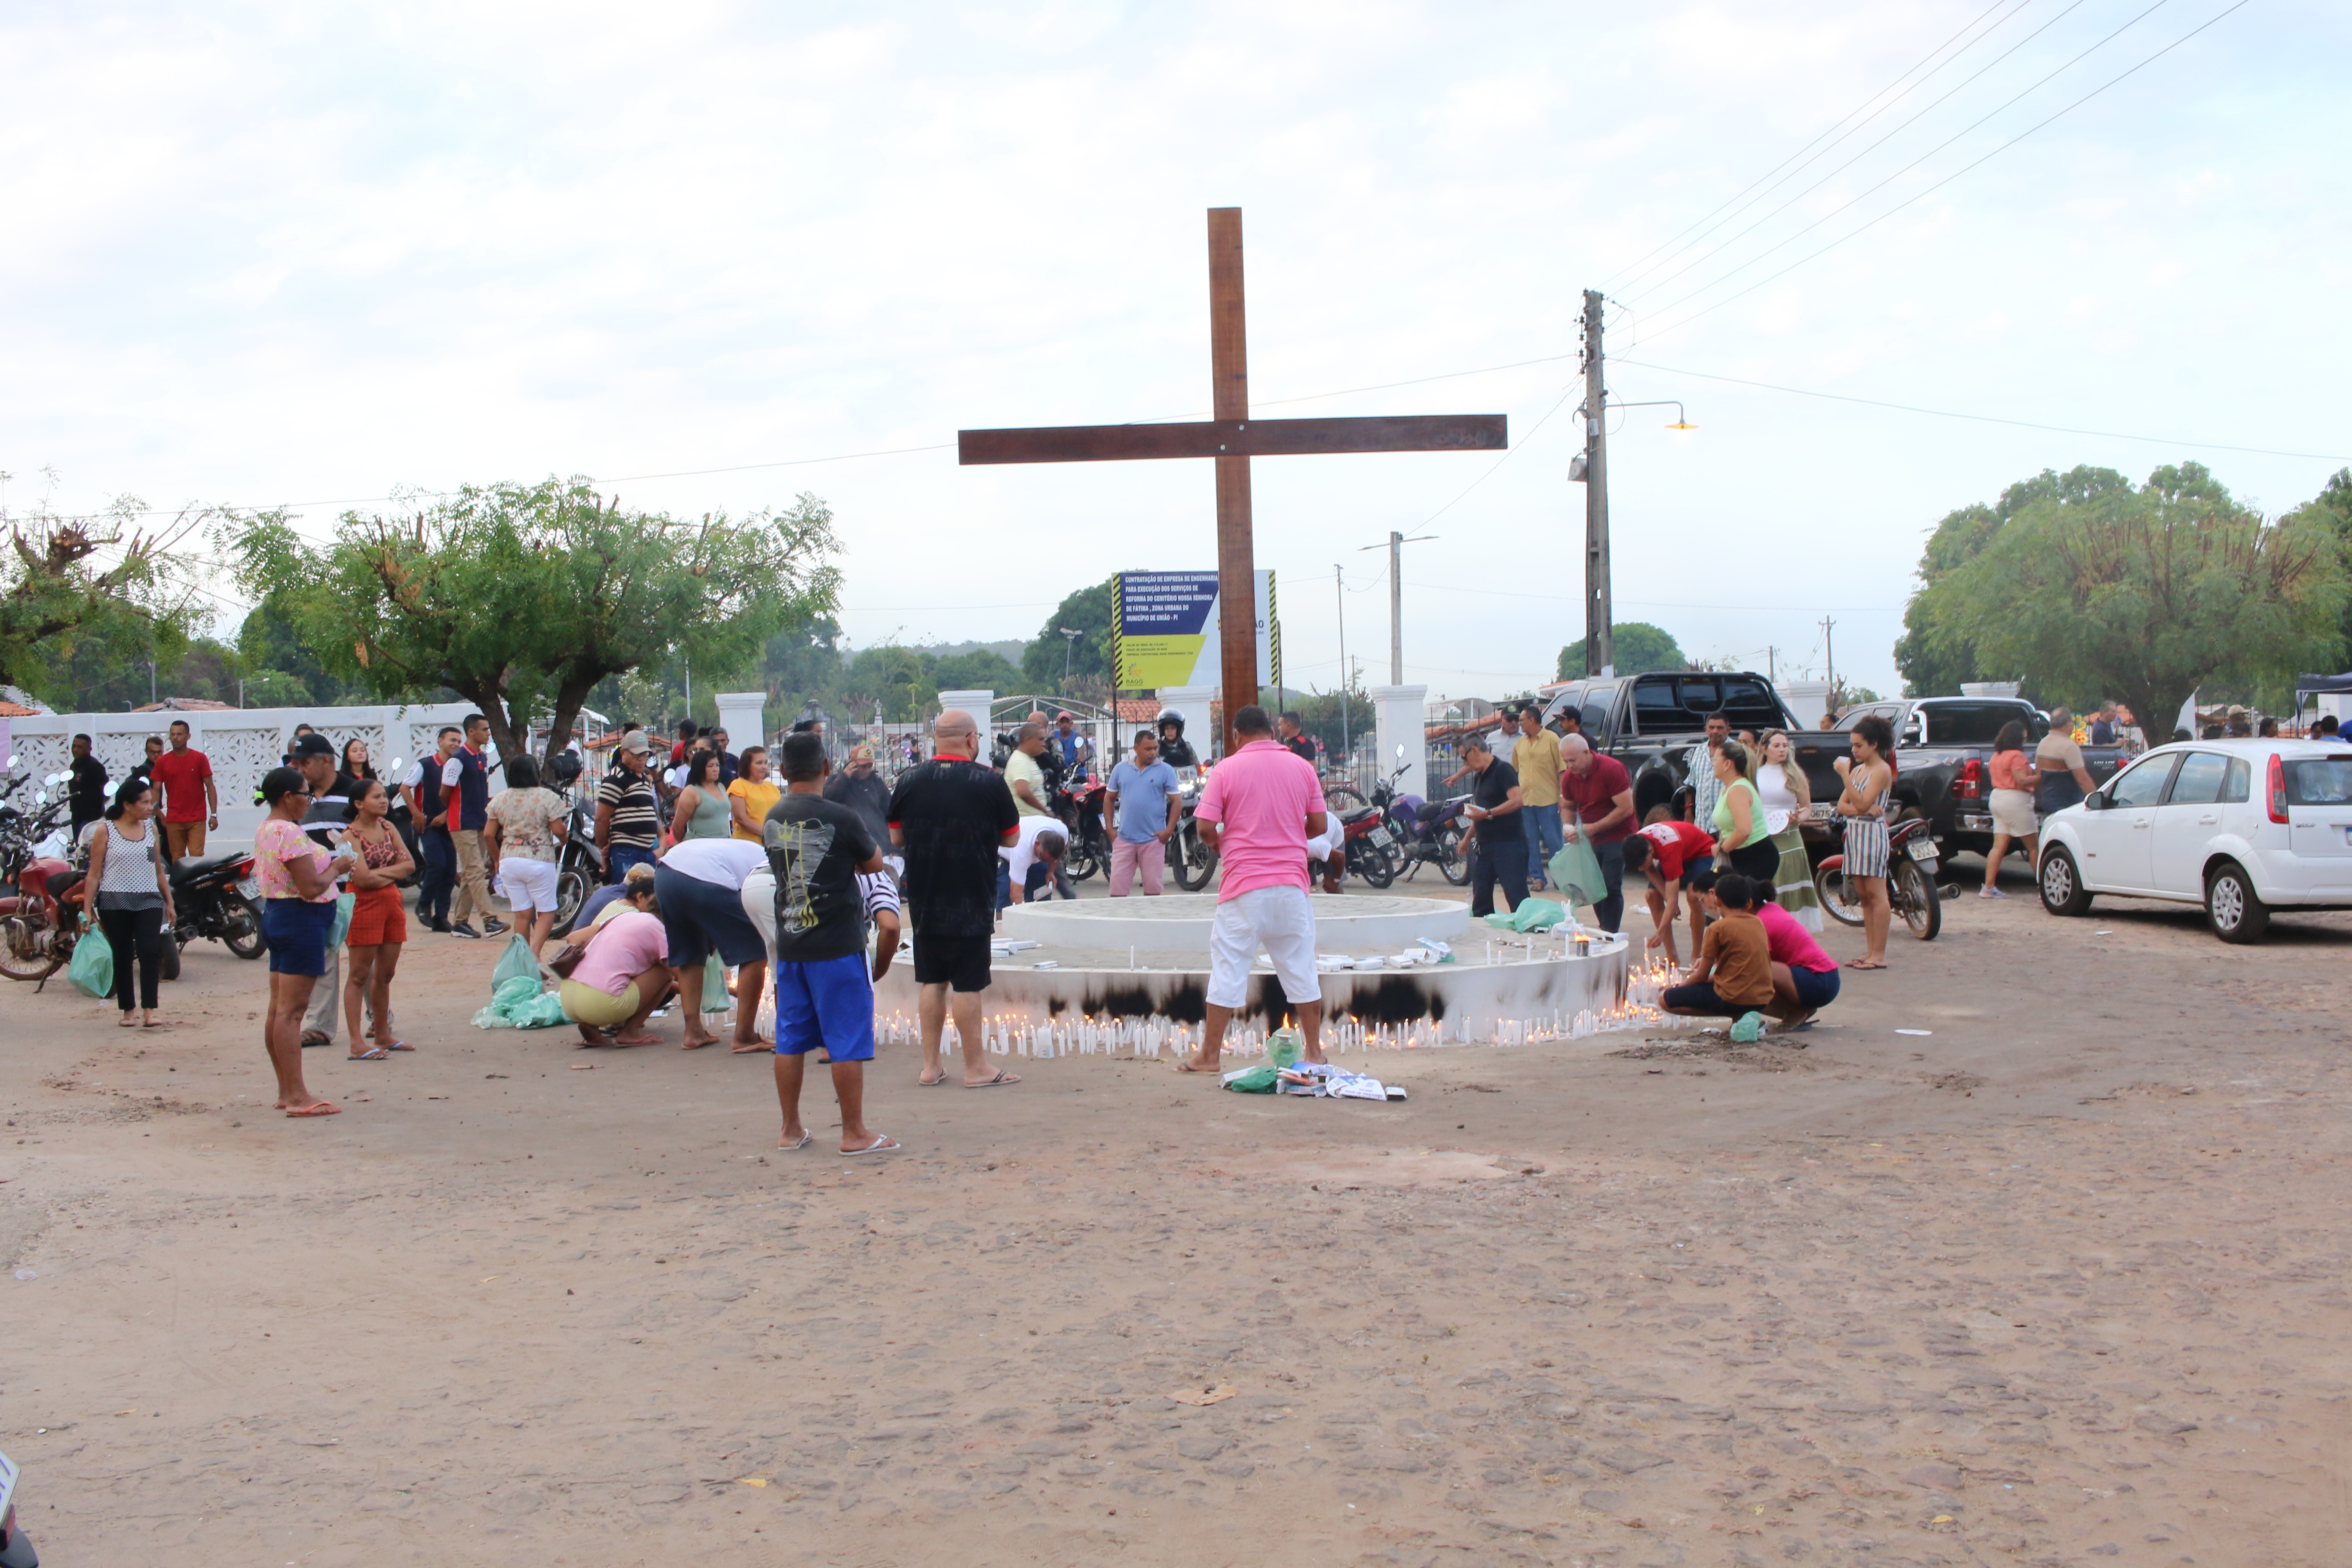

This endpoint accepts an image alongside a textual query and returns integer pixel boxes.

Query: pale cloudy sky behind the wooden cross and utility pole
[0,0,2352,693]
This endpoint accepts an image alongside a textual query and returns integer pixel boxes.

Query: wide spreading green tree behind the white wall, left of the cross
[224,480,840,752]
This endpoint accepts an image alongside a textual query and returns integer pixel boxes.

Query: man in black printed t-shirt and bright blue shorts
[760,736,898,1154]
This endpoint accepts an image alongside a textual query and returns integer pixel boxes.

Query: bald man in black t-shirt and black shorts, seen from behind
[889,707,1021,1088]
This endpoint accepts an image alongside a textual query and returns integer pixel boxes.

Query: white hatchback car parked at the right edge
[2039,741,2352,943]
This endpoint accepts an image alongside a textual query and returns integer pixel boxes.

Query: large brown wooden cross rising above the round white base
[955,207,1508,750]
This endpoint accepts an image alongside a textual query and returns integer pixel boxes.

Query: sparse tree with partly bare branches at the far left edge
[0,496,214,703]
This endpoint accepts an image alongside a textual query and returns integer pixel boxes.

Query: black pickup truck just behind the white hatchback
[1797,696,2126,861]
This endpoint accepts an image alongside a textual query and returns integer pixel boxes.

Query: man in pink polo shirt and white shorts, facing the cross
[1178,703,1324,1072]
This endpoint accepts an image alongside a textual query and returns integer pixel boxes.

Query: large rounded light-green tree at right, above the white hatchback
[1929,463,2347,736]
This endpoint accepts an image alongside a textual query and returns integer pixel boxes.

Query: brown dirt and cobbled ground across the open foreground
[0,861,2352,1568]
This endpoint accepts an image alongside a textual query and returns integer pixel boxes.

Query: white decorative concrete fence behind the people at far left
[0,703,473,851]
